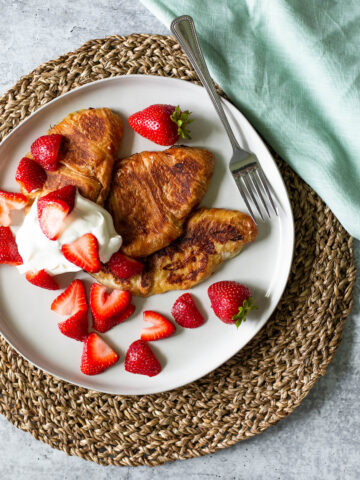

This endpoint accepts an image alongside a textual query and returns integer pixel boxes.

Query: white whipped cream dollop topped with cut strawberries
[16,192,122,275]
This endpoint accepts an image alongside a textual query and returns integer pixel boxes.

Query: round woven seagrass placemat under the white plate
[0,35,355,465]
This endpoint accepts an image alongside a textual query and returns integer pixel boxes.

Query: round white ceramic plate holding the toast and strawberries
[0,75,294,395]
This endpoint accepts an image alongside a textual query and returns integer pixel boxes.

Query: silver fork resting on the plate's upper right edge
[170,15,278,221]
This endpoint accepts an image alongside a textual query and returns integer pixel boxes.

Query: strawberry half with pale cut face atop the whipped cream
[37,185,76,240]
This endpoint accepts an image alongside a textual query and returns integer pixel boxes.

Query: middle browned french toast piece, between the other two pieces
[107,146,214,257]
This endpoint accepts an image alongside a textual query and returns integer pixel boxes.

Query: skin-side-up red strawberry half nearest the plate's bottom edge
[125,340,161,377]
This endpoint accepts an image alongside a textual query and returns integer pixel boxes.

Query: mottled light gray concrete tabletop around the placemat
[0,0,360,480]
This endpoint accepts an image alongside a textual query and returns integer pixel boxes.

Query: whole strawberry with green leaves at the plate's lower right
[208,281,258,327]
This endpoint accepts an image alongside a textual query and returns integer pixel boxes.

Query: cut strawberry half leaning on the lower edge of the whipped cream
[61,233,101,273]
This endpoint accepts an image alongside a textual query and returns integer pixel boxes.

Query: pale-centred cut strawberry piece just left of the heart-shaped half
[51,280,88,315]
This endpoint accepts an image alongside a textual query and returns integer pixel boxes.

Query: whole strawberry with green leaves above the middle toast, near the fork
[129,104,192,145]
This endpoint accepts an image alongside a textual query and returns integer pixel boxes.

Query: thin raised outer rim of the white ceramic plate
[0,74,295,396]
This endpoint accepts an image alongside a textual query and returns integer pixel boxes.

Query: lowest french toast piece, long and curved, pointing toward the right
[93,208,257,297]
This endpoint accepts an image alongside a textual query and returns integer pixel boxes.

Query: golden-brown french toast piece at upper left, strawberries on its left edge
[23,108,123,205]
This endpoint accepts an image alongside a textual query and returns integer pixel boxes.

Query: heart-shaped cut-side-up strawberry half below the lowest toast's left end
[90,283,131,328]
